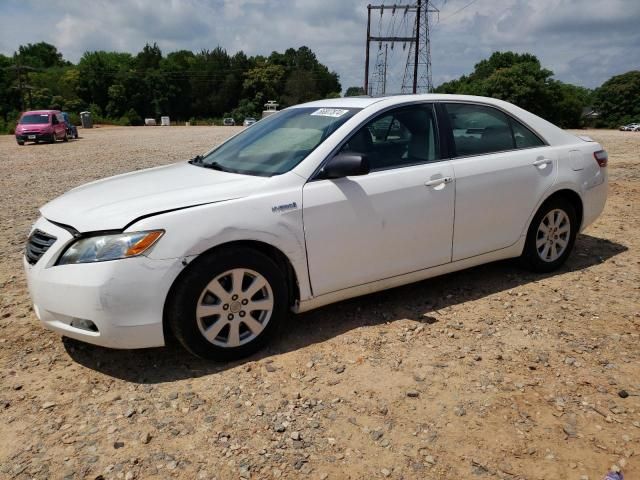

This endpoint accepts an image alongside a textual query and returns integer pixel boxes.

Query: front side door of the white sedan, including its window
[303,104,455,296]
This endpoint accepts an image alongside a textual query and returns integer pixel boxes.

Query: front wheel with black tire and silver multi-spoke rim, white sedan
[165,247,289,361]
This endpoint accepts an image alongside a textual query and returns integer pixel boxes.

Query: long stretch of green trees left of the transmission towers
[0,42,342,130]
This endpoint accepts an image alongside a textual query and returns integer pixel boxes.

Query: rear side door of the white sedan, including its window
[444,103,557,261]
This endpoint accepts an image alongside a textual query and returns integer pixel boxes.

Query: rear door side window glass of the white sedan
[446,103,544,157]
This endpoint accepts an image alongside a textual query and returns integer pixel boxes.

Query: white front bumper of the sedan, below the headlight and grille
[24,218,183,348]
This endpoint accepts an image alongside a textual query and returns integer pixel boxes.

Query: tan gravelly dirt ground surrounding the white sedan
[0,127,640,480]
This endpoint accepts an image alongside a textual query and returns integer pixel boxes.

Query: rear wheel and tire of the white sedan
[520,197,579,273]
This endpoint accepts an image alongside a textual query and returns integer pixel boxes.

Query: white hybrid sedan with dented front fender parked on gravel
[24,95,607,359]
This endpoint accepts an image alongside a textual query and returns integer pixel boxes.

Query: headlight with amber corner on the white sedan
[58,230,164,265]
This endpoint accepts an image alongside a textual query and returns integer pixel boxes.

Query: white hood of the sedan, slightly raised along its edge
[40,162,269,232]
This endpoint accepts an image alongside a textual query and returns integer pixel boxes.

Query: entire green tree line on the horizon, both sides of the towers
[0,42,640,132]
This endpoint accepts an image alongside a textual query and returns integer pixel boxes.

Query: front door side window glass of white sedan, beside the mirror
[342,105,440,171]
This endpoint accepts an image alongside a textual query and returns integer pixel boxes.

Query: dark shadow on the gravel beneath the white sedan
[63,235,627,384]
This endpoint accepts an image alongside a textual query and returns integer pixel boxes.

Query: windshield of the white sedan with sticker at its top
[192,107,359,177]
